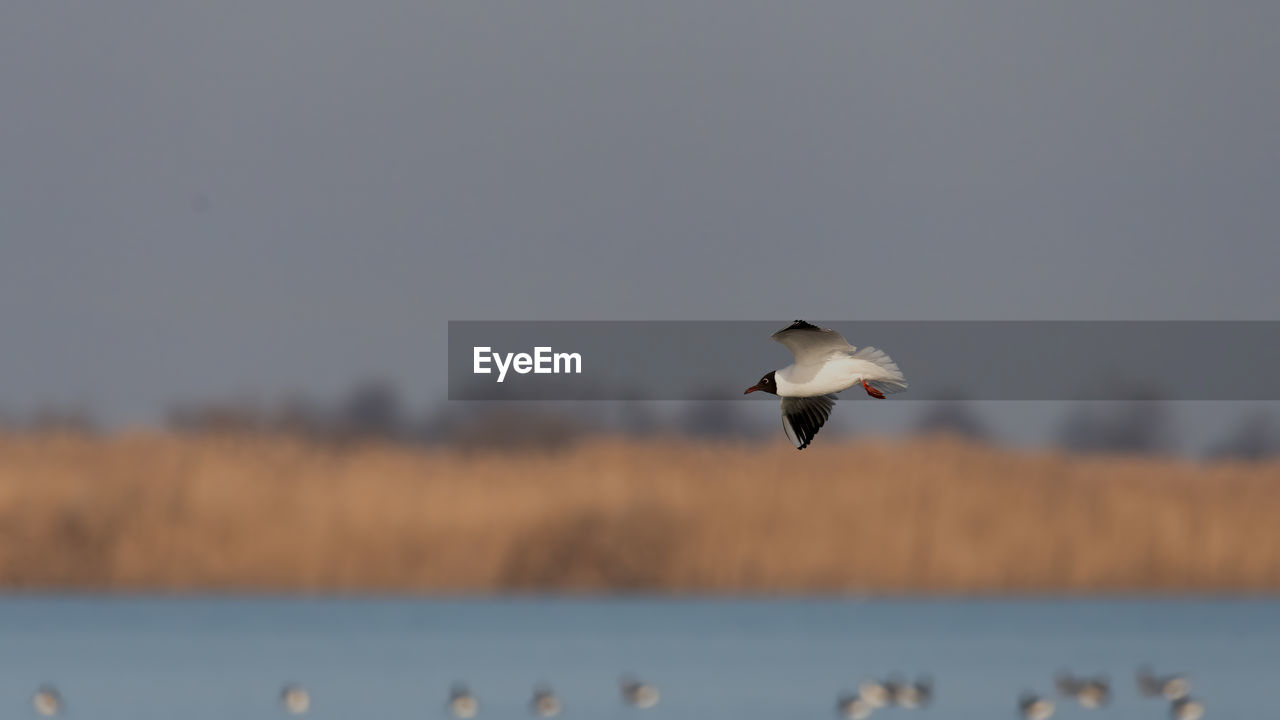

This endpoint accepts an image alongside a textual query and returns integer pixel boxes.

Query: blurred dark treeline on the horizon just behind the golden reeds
[12,379,1280,460]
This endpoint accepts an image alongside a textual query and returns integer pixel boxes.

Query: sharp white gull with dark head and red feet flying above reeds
[744,320,906,450]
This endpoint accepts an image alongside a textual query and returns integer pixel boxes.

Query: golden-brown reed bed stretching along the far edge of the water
[0,433,1280,593]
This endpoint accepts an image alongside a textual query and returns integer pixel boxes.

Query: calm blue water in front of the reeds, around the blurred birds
[0,597,1280,720]
